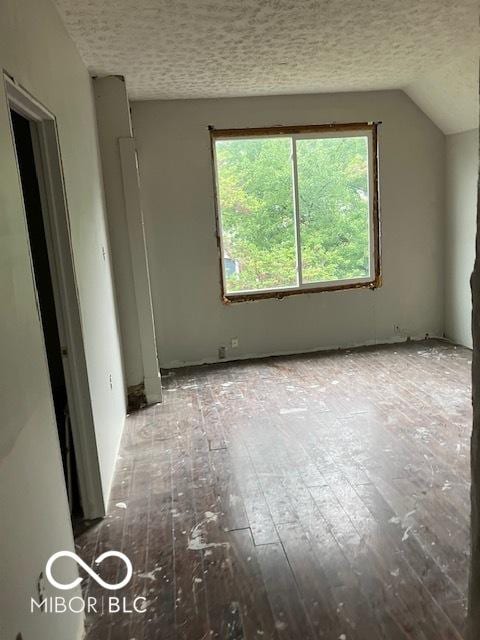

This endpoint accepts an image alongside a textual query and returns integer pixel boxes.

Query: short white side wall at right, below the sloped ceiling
[445,129,478,347]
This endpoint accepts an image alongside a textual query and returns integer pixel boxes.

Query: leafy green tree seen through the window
[216,137,369,292]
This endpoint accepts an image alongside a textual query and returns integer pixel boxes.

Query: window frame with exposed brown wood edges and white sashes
[209,122,382,304]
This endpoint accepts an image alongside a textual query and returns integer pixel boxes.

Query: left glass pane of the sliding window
[216,138,297,293]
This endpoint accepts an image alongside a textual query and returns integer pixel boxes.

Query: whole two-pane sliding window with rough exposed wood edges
[211,124,380,300]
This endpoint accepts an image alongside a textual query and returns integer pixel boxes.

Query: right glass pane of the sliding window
[297,136,370,283]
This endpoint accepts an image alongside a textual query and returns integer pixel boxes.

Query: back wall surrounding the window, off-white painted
[132,91,445,366]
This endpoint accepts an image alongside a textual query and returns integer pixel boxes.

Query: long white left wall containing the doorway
[0,0,125,640]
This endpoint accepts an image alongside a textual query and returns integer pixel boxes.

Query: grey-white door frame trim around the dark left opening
[4,73,106,520]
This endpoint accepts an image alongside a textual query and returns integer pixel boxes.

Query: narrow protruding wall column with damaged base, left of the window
[93,76,162,406]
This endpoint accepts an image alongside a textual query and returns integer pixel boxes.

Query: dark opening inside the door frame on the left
[11,110,82,519]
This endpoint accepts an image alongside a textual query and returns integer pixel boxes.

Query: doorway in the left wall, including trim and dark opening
[4,74,105,524]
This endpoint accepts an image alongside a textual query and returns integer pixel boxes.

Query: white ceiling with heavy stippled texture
[55,0,479,132]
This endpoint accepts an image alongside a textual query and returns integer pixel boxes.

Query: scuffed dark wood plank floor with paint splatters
[76,341,471,640]
